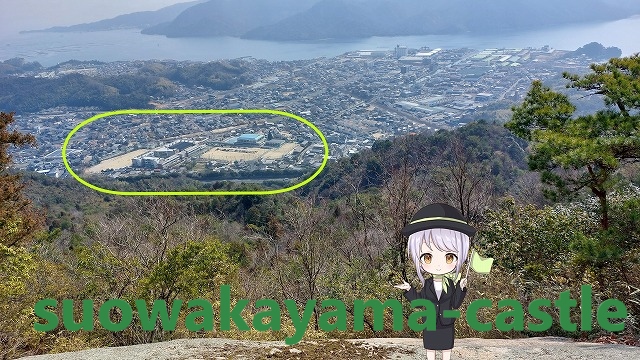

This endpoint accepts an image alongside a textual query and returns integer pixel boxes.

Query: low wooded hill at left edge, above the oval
[0,59,252,112]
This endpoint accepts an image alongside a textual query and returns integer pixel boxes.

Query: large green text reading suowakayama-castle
[34,285,627,345]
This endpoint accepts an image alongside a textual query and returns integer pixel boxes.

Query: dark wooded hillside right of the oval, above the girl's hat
[305,121,526,201]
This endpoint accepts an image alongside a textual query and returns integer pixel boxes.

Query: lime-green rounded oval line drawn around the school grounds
[62,109,329,196]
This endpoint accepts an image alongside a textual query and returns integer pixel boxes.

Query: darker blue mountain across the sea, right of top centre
[245,0,630,40]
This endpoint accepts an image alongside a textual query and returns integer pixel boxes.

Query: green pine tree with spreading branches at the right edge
[505,55,640,229]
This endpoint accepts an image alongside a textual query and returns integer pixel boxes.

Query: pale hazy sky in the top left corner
[0,0,195,33]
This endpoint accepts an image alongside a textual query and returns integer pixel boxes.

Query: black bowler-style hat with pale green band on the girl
[402,204,476,237]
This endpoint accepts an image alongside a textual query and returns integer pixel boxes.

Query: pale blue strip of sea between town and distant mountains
[0,15,640,66]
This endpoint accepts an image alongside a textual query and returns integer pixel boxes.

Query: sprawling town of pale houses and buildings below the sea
[7,46,594,180]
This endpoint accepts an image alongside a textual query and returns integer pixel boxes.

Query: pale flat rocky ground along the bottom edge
[17,337,640,360]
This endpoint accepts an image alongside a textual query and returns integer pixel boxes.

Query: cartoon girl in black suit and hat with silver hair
[395,204,476,360]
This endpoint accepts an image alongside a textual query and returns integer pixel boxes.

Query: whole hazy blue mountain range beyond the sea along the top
[22,0,640,41]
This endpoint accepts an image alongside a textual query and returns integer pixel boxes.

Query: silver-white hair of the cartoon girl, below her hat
[407,228,470,283]
